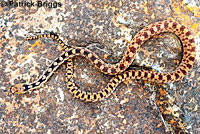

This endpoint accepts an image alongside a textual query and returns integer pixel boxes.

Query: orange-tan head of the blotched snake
[8,84,24,95]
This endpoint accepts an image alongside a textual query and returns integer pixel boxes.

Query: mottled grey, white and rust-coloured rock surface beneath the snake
[0,0,200,134]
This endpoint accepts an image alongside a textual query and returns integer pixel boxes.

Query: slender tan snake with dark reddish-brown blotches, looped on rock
[8,21,195,102]
